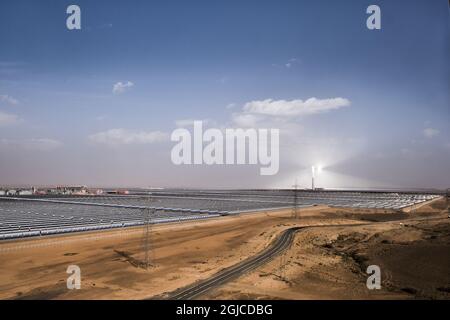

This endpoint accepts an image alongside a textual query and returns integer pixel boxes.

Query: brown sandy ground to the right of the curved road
[206,200,450,299]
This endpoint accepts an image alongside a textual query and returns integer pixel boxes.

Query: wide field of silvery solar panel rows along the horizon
[0,190,438,240]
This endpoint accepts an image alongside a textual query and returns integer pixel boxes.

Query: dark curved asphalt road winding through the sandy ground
[163,227,301,300]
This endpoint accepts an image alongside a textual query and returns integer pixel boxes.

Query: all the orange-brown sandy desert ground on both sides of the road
[0,201,450,299]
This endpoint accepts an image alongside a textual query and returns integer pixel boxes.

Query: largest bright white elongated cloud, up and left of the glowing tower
[243,97,350,117]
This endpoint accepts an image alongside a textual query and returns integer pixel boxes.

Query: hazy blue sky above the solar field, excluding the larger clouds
[0,0,450,187]
